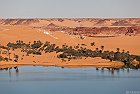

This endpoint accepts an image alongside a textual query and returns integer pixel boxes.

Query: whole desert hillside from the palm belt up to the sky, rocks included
[0,18,140,55]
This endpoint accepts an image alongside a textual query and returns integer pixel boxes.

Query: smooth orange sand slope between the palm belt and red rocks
[0,26,140,55]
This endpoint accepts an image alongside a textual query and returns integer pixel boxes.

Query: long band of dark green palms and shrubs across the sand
[0,40,140,67]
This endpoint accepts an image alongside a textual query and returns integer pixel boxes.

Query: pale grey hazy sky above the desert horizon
[0,0,140,18]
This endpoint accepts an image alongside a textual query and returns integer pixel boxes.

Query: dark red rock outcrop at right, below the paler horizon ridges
[46,27,140,36]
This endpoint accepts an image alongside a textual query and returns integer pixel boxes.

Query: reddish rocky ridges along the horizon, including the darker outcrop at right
[0,18,140,35]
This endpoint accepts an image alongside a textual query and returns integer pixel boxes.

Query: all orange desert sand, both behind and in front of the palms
[0,19,140,68]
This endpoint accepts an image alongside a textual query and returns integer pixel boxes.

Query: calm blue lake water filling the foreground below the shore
[0,67,140,94]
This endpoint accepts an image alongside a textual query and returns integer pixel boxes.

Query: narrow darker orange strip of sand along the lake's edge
[0,62,124,69]
